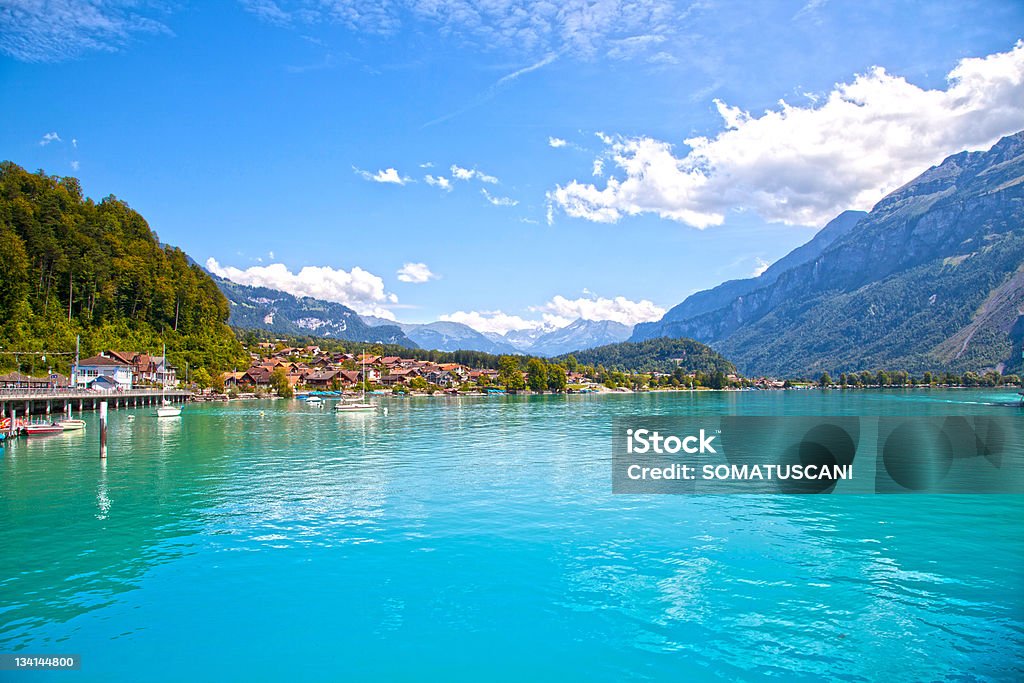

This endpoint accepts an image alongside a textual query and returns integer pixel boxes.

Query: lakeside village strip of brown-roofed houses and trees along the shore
[0,340,1020,400]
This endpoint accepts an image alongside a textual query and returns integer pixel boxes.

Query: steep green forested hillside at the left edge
[0,162,245,373]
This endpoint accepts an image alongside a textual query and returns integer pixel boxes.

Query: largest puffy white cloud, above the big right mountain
[548,42,1024,228]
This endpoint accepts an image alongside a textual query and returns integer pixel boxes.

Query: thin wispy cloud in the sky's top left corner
[0,0,172,61]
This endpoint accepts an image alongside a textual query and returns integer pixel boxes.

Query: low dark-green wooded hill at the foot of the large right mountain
[554,337,736,375]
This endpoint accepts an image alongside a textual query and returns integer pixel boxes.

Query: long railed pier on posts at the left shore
[0,388,191,418]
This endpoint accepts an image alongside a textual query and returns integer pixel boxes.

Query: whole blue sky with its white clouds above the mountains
[0,0,1024,332]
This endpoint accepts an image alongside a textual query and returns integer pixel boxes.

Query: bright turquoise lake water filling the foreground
[0,390,1024,681]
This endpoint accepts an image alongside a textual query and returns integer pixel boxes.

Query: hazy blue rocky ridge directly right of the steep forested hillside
[211,275,418,348]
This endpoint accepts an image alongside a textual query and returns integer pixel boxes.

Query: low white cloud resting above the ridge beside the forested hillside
[206,258,398,321]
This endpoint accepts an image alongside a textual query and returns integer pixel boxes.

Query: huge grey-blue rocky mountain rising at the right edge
[633,132,1024,375]
